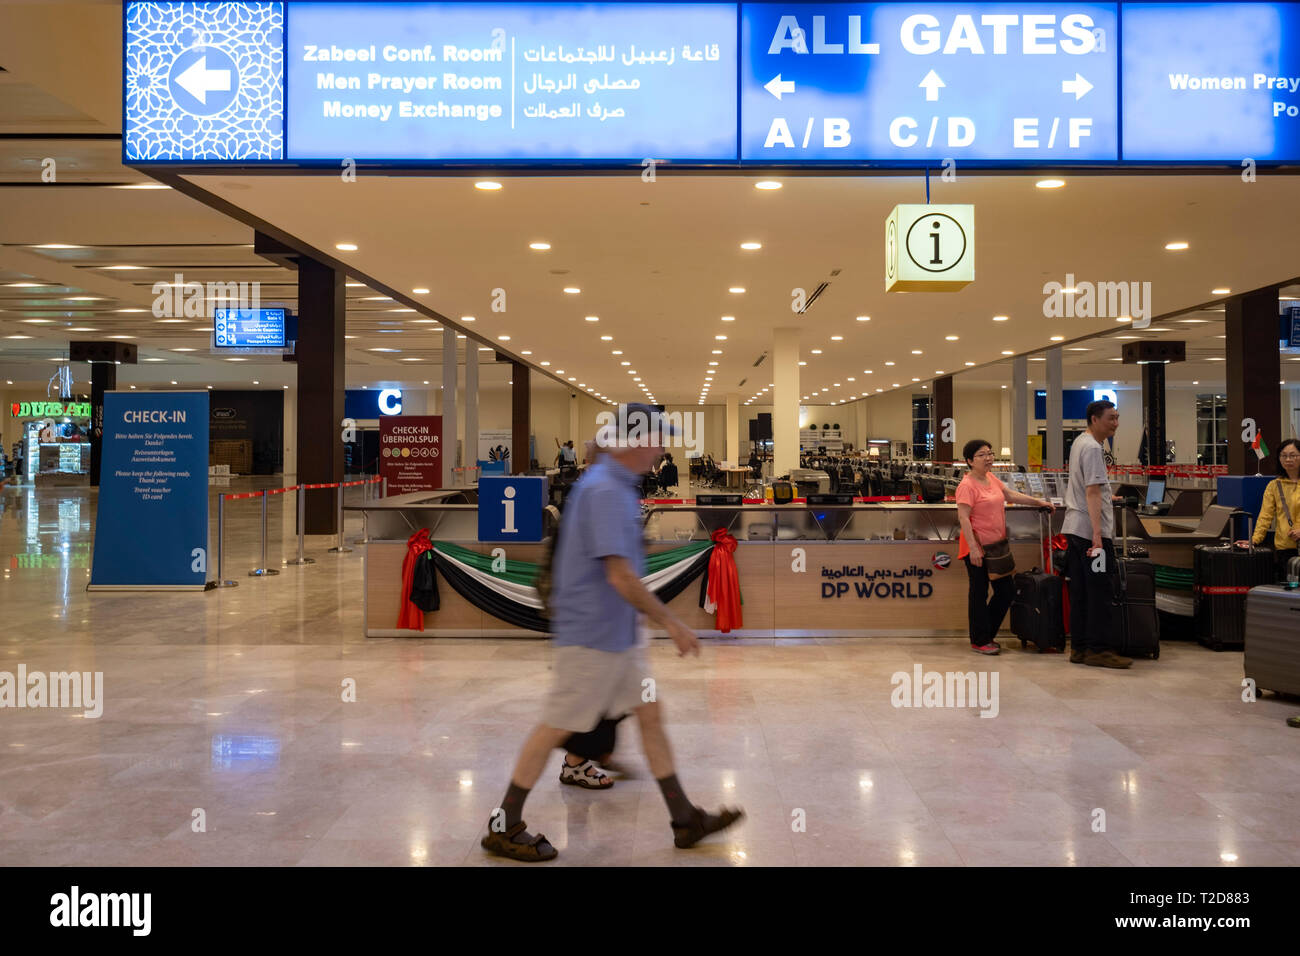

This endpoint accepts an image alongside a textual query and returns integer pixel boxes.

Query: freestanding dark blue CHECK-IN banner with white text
[90,392,208,591]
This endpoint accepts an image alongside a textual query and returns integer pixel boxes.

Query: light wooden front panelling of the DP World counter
[365,540,1041,637]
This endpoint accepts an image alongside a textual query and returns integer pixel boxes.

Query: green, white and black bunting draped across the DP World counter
[399,541,714,632]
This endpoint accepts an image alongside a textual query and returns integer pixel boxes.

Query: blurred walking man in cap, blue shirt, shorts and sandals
[481,403,744,862]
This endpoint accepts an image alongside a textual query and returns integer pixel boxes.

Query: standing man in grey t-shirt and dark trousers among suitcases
[1061,401,1132,667]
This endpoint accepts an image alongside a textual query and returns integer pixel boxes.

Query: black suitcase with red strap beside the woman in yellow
[1192,544,1274,650]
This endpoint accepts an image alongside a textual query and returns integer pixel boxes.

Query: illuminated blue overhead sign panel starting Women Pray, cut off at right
[1122,3,1300,163]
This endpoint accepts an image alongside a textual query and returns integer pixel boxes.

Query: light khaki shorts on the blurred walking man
[542,644,650,734]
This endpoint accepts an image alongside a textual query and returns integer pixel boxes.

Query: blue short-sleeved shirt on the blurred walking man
[550,455,646,652]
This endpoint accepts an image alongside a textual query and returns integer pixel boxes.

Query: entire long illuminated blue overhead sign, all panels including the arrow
[122,0,1300,168]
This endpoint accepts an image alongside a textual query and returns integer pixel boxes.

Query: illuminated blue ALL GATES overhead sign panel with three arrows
[741,3,1119,163]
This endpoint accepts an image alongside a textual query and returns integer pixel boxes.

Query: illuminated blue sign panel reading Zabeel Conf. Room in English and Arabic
[287,3,736,161]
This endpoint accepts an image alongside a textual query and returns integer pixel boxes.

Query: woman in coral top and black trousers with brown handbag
[957,438,1052,654]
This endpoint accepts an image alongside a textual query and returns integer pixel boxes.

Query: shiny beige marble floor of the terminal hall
[0,488,1300,866]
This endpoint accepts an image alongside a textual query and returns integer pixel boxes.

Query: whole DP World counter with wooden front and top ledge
[350,496,1060,637]
